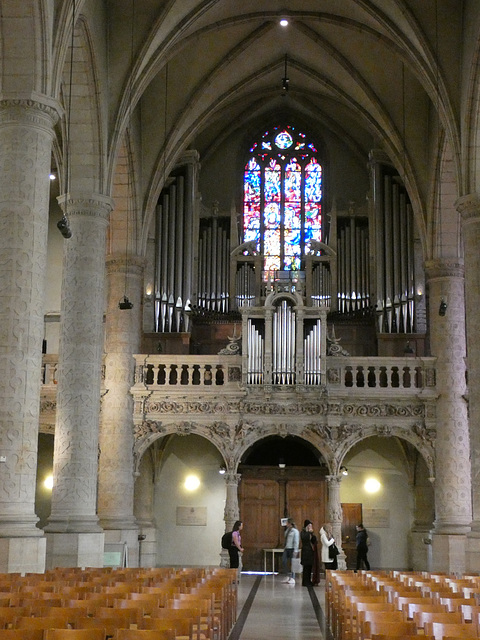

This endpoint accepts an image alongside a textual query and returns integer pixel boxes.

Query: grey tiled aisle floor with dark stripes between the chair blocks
[229,574,331,640]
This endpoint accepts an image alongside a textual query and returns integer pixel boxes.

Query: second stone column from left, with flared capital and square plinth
[45,195,112,568]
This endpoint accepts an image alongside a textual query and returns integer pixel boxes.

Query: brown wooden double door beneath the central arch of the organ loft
[239,467,326,571]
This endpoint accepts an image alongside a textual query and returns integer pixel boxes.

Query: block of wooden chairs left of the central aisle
[0,567,237,640]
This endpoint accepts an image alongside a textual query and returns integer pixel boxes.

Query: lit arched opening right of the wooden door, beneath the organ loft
[340,436,435,569]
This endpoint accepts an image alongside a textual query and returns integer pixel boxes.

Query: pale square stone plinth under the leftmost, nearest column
[0,536,47,573]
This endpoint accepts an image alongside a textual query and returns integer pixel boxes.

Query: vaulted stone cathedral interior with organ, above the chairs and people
[0,0,480,573]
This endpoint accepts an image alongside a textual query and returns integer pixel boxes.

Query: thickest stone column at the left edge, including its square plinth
[0,100,58,572]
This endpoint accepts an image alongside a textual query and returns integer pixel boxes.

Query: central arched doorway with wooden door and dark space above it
[238,436,328,571]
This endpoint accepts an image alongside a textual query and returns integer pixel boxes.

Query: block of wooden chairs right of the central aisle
[325,571,480,640]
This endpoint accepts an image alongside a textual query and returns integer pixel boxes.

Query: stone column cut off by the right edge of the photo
[456,193,480,572]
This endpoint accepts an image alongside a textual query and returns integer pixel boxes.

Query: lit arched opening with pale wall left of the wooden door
[134,434,225,566]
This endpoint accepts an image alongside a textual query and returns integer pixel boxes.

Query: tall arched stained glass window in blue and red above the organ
[243,126,322,271]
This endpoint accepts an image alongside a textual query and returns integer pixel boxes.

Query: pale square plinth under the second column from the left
[45,531,105,569]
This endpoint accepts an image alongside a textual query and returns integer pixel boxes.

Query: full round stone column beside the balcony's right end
[426,260,470,573]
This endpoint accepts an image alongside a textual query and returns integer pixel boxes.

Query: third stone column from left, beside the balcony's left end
[98,255,143,567]
